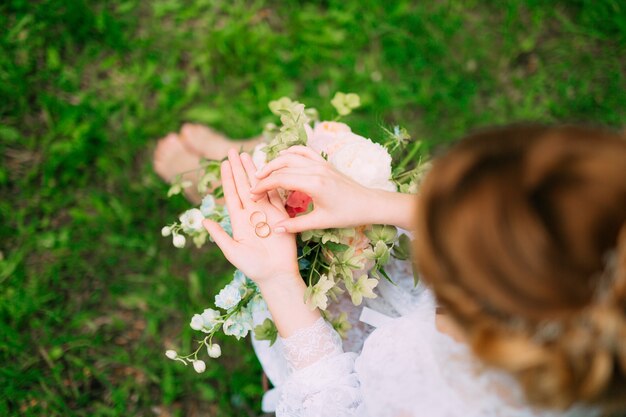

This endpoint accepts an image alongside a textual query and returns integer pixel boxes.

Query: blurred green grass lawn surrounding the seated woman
[0,0,626,417]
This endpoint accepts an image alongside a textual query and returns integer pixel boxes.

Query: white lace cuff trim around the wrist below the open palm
[280,317,343,370]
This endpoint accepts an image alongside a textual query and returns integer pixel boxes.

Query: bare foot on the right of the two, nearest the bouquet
[180,123,263,161]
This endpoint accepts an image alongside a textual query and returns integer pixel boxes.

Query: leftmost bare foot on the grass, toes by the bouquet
[153,133,202,204]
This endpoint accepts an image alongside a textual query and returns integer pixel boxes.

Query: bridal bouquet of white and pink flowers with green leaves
[161,93,428,372]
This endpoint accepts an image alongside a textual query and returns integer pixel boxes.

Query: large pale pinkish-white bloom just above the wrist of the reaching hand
[329,139,397,191]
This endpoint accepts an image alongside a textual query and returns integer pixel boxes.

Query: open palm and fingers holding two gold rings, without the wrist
[204,149,301,286]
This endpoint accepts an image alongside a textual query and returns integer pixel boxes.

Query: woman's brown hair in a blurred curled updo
[415,126,626,409]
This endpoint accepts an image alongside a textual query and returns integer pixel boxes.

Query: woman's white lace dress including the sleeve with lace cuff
[253,262,599,417]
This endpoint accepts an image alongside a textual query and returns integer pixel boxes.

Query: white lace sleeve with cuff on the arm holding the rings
[276,318,362,417]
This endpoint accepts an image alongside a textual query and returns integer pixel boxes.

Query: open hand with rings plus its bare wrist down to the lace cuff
[204,150,320,337]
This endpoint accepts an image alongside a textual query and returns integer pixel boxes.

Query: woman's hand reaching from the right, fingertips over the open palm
[251,146,415,233]
